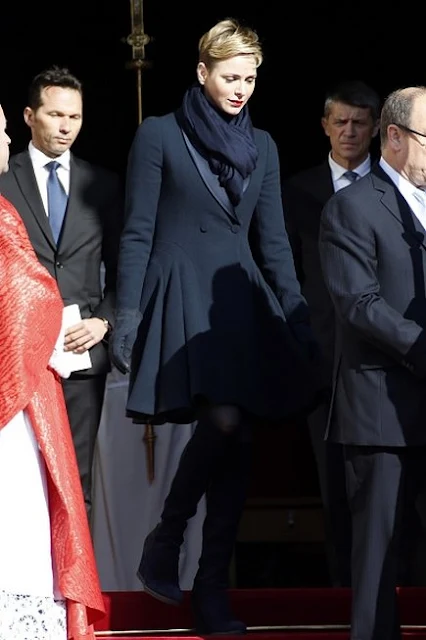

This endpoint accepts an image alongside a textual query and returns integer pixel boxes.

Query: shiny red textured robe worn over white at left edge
[0,196,104,640]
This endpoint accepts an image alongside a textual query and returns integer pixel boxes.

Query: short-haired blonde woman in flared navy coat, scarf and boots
[111,19,322,634]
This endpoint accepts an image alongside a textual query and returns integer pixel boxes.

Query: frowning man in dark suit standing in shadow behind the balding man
[283,81,380,586]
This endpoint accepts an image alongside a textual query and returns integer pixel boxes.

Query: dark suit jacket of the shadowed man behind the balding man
[282,161,335,384]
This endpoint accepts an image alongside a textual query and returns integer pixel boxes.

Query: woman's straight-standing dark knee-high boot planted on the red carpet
[192,436,252,635]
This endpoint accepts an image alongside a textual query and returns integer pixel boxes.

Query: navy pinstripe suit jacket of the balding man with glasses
[319,165,426,446]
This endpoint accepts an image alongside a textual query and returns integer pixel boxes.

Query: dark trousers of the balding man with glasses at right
[345,445,426,640]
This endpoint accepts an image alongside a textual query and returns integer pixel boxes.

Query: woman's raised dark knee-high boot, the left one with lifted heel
[137,420,230,604]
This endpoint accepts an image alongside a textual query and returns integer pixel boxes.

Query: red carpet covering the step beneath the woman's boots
[96,588,426,640]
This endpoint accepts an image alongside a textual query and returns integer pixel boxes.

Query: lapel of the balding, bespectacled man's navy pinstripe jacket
[371,165,426,250]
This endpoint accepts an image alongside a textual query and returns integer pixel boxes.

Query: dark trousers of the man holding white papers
[62,374,106,522]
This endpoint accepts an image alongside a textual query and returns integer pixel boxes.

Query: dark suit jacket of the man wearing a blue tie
[0,151,123,375]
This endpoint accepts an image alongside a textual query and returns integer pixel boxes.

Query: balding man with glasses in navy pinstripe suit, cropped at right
[319,87,426,640]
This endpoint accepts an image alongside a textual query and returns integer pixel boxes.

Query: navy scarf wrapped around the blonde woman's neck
[178,84,258,206]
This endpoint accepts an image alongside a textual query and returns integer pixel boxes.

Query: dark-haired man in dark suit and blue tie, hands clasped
[0,67,122,518]
